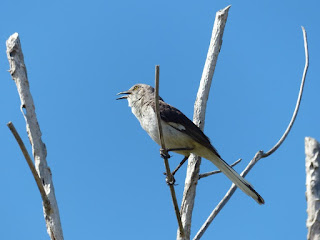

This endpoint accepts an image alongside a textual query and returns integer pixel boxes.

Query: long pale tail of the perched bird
[209,154,264,204]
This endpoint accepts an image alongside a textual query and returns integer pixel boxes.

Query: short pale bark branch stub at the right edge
[304,137,320,240]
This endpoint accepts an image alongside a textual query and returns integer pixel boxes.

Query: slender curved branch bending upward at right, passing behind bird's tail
[193,27,309,240]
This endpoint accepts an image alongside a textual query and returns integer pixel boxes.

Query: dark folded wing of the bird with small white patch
[153,100,221,158]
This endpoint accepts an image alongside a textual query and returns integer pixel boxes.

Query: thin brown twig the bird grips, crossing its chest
[155,65,184,238]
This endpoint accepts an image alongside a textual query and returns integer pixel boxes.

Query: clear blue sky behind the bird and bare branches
[0,0,320,240]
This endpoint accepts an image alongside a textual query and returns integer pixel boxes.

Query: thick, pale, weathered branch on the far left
[6,33,63,240]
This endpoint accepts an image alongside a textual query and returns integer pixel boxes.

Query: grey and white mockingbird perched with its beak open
[117,84,264,204]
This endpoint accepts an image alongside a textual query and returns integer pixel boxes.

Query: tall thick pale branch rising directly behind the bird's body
[177,5,231,240]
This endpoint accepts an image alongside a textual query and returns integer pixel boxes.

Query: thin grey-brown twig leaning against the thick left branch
[7,122,51,214]
